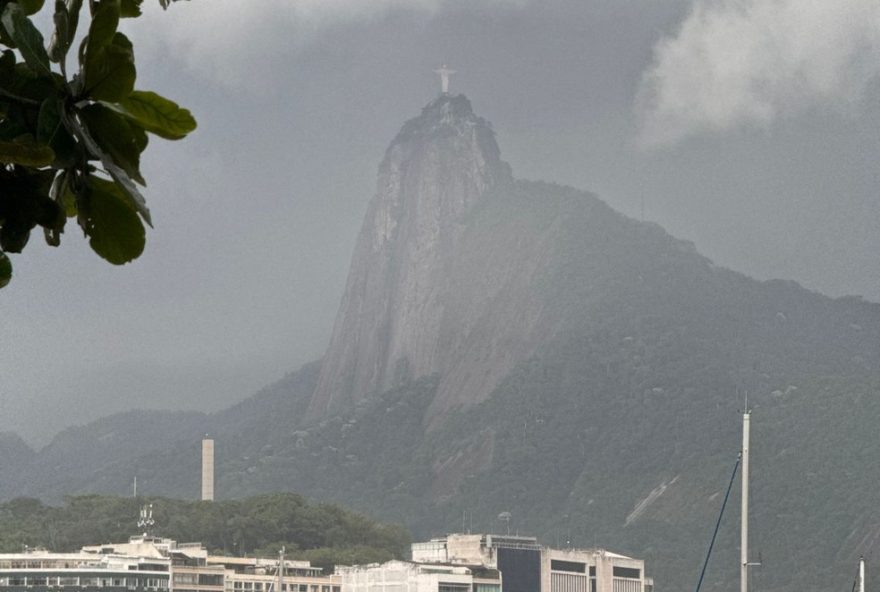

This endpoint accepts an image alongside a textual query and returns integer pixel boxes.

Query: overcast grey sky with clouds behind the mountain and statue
[0,0,880,443]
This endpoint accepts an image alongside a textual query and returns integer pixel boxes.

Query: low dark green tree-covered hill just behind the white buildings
[0,493,409,571]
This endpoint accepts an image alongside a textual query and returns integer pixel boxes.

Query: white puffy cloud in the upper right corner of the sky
[637,0,880,146]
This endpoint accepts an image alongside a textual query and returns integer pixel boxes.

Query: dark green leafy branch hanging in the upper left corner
[0,0,196,288]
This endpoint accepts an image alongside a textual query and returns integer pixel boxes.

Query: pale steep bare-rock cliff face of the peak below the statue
[308,95,511,418]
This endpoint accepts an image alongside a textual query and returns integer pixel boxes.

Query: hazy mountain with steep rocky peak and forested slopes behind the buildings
[0,96,880,592]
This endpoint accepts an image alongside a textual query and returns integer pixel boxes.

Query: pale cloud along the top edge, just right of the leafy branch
[133,0,528,88]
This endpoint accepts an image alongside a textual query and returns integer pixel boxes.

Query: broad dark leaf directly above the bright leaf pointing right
[85,33,137,102]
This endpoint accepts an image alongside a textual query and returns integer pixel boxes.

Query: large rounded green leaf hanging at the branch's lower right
[83,176,147,265]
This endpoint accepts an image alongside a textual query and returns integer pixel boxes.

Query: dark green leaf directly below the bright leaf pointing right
[80,103,147,185]
